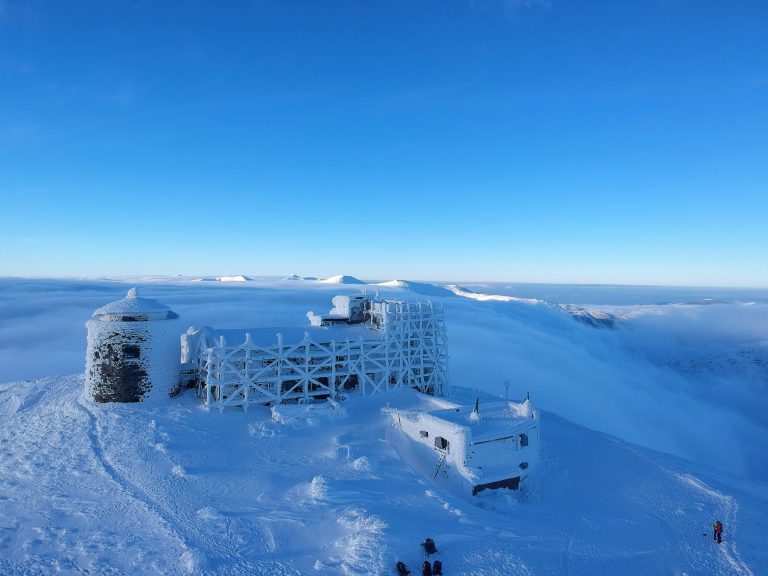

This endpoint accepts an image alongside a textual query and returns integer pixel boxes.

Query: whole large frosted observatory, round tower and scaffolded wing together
[85,288,448,409]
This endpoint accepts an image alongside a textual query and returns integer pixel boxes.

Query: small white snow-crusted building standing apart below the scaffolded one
[386,400,539,495]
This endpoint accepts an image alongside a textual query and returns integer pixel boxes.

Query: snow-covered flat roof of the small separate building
[429,400,535,442]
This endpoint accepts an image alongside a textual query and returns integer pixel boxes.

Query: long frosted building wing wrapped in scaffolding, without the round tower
[182,296,448,409]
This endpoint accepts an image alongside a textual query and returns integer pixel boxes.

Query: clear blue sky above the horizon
[0,0,768,287]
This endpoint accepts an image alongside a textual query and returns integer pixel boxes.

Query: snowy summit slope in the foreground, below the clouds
[0,376,766,576]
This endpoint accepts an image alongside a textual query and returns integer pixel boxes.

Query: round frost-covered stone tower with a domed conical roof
[85,288,181,402]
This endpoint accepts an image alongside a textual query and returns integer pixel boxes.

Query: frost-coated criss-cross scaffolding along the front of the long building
[188,301,448,410]
